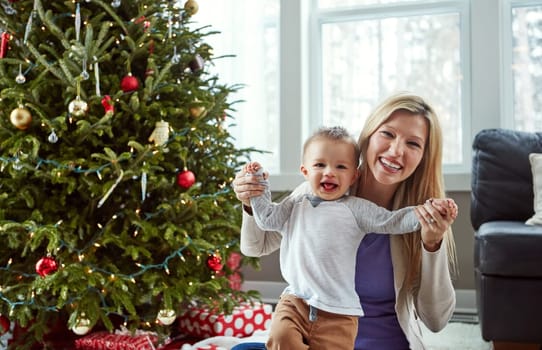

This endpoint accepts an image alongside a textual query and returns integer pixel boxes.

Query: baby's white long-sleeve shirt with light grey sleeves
[251,191,420,316]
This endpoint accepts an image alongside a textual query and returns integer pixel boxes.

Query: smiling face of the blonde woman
[366,110,428,185]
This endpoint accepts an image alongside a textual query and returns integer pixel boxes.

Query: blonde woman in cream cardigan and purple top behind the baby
[233,93,456,350]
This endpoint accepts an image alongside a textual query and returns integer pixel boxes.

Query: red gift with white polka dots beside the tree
[179,303,273,338]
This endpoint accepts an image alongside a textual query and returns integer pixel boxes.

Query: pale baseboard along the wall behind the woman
[243,281,478,323]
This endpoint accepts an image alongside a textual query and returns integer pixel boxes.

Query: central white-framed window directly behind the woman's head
[311,0,469,171]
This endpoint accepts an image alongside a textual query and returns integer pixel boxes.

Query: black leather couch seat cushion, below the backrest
[474,221,542,278]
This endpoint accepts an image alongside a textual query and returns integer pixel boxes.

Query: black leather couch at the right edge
[470,129,542,348]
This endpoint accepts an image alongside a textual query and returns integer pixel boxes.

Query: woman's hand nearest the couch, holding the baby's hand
[415,198,458,252]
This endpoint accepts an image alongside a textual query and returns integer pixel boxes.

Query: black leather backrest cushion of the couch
[471,129,542,230]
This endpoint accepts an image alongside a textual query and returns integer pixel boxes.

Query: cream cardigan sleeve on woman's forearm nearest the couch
[415,239,456,332]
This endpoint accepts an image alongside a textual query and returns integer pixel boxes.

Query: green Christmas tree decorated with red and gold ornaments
[0,0,260,348]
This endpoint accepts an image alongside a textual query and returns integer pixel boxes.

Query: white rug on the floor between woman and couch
[422,322,492,350]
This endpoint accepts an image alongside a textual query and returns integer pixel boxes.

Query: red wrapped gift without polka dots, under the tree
[75,331,158,350]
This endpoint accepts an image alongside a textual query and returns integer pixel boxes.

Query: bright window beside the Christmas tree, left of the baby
[192,0,281,173]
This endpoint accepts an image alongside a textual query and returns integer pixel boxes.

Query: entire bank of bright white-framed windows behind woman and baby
[188,0,542,191]
